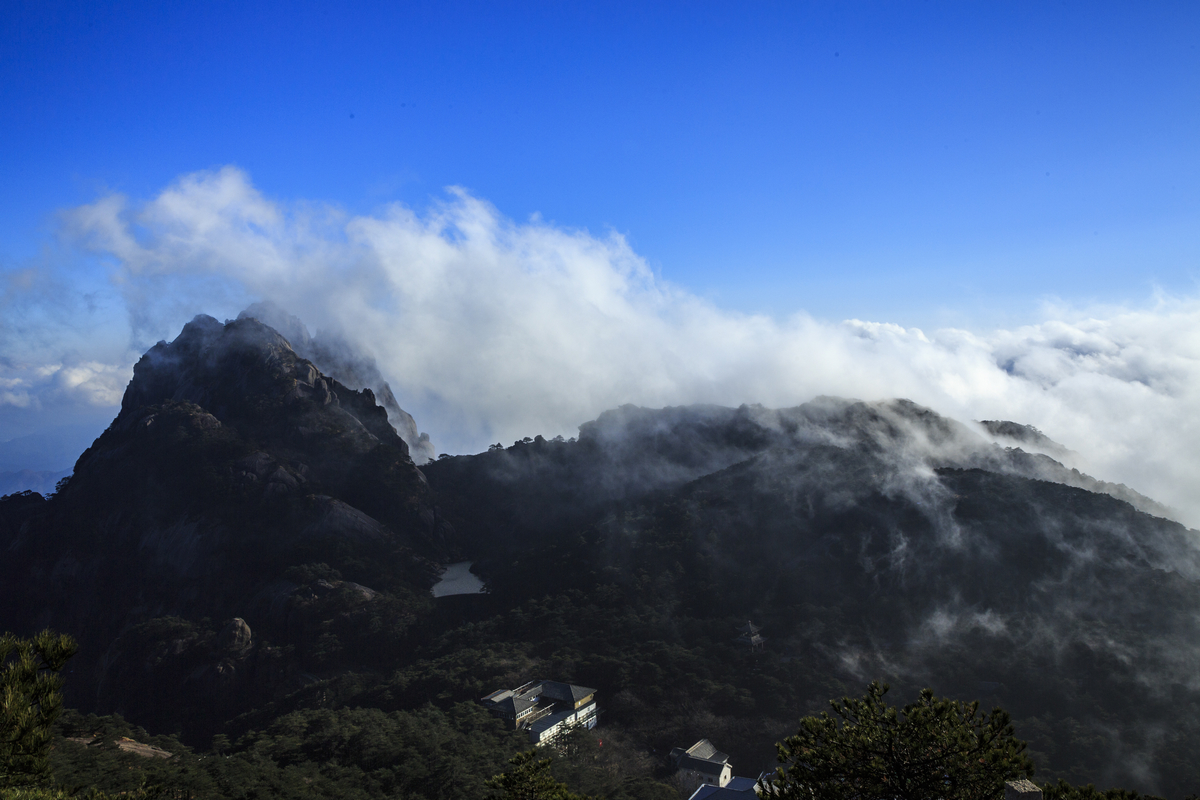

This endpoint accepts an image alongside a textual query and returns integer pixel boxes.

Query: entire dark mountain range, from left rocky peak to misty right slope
[0,316,1200,798]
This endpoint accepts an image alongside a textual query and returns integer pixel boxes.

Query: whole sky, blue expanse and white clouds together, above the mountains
[0,0,1200,521]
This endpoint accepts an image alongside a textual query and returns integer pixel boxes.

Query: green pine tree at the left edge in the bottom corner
[0,630,77,788]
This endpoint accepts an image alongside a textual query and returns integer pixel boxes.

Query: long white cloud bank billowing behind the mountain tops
[0,167,1200,524]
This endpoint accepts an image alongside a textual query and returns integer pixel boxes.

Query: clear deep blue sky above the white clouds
[0,2,1200,326]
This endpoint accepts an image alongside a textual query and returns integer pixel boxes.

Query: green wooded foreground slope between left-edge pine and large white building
[45,703,523,800]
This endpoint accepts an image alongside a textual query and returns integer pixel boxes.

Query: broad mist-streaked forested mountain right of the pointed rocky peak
[426,398,1200,794]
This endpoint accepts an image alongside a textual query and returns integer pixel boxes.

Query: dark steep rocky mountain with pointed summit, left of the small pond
[0,315,452,743]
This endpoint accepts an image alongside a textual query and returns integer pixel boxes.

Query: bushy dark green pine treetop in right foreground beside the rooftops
[762,681,1033,800]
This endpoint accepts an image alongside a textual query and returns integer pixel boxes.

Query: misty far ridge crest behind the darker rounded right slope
[425,397,1168,561]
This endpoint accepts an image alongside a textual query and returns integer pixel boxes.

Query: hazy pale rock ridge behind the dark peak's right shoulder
[238,301,436,465]
